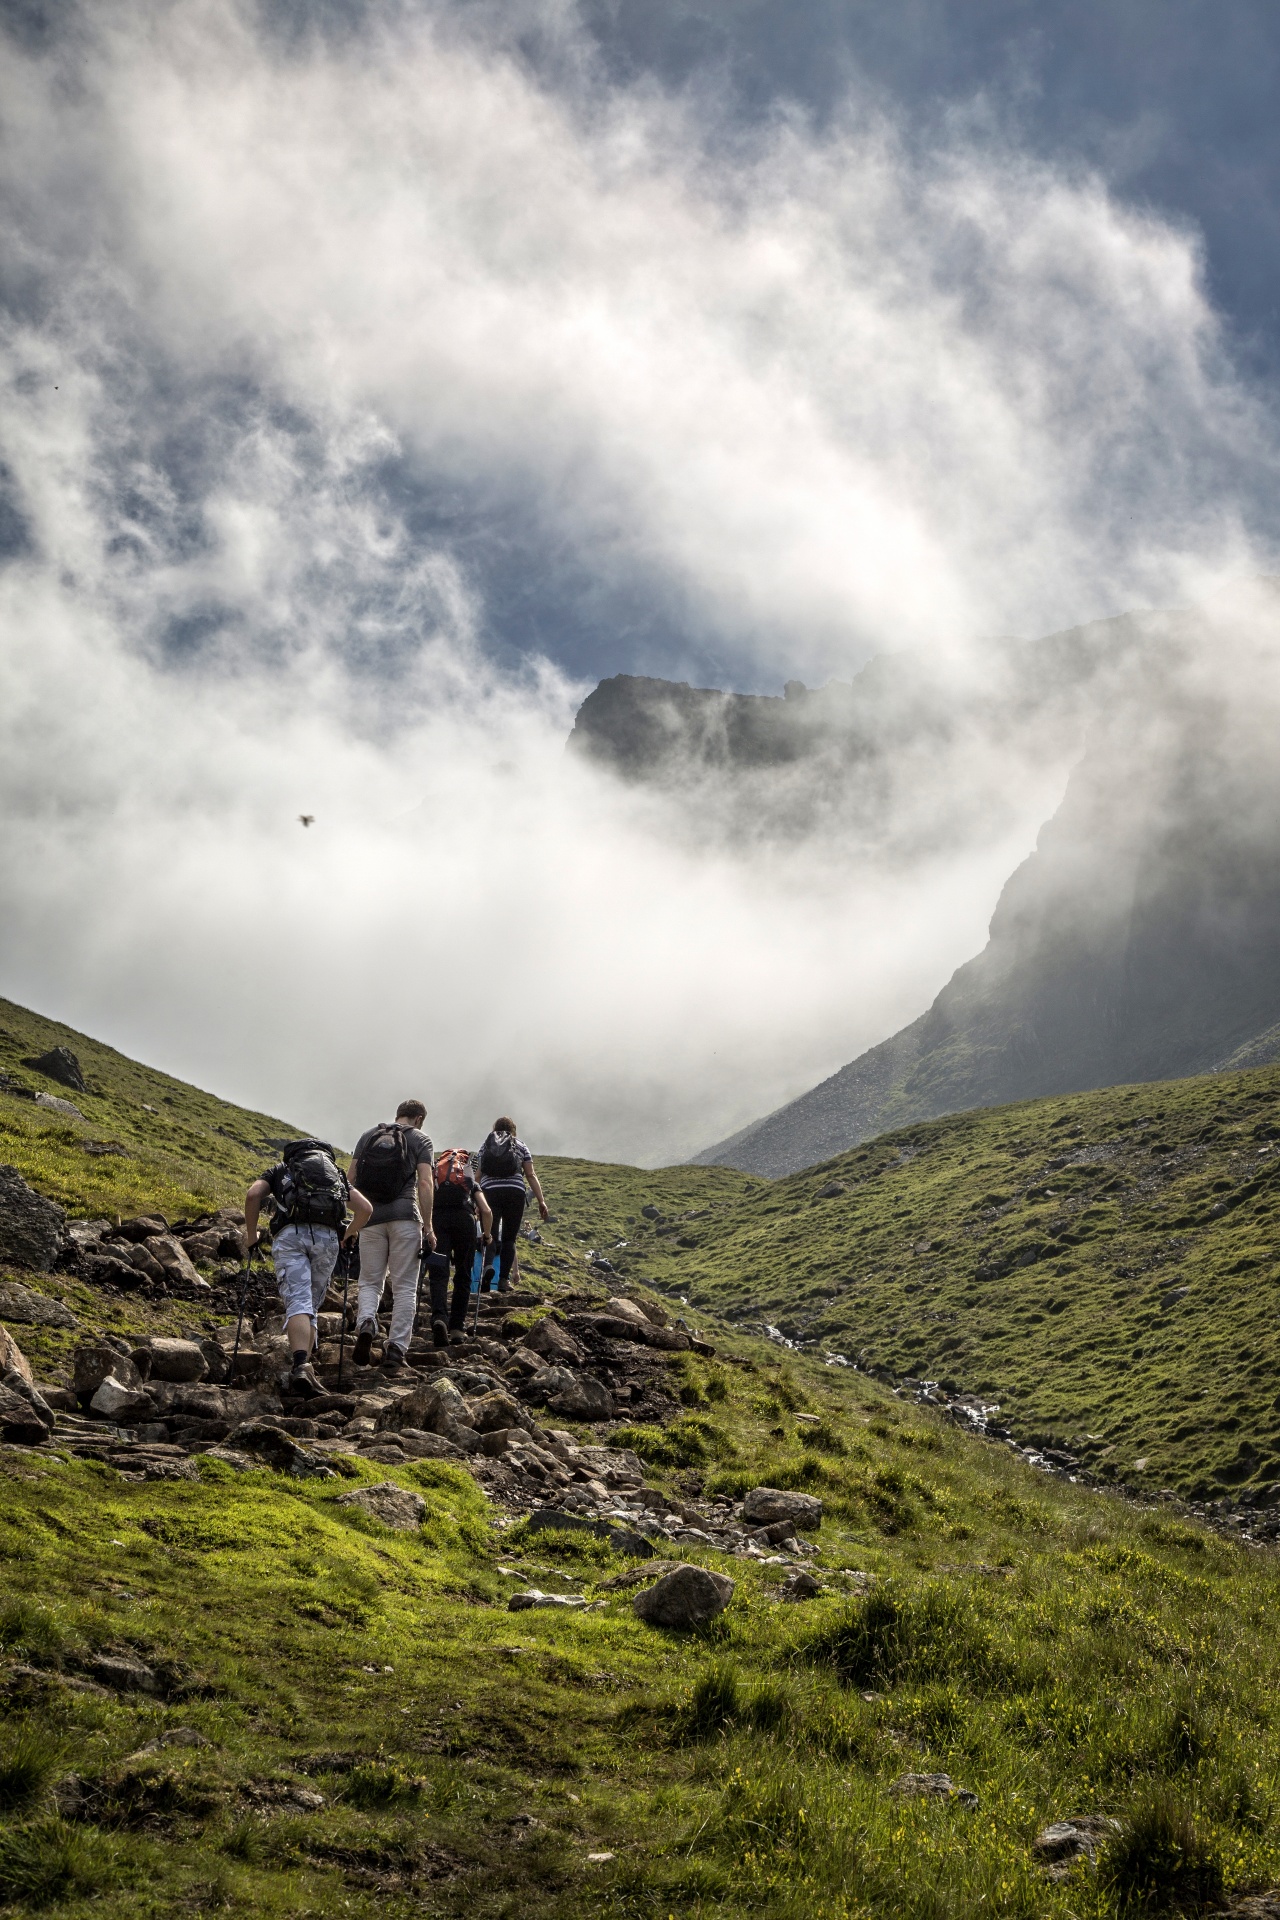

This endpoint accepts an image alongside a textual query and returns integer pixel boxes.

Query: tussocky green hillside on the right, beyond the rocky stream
[594,1068,1280,1498]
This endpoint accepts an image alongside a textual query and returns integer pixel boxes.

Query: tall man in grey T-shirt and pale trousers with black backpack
[351,1100,436,1377]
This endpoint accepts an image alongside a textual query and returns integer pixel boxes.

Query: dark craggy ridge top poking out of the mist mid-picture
[568,616,1153,860]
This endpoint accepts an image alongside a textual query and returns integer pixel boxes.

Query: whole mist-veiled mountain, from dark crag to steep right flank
[574,584,1280,1175]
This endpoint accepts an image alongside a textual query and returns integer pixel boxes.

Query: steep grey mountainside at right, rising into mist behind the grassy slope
[697,587,1280,1175]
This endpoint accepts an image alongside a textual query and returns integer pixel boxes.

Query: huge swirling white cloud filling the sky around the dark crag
[0,0,1274,1160]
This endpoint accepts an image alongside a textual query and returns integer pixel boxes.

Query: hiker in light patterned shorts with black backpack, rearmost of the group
[244,1140,372,1398]
